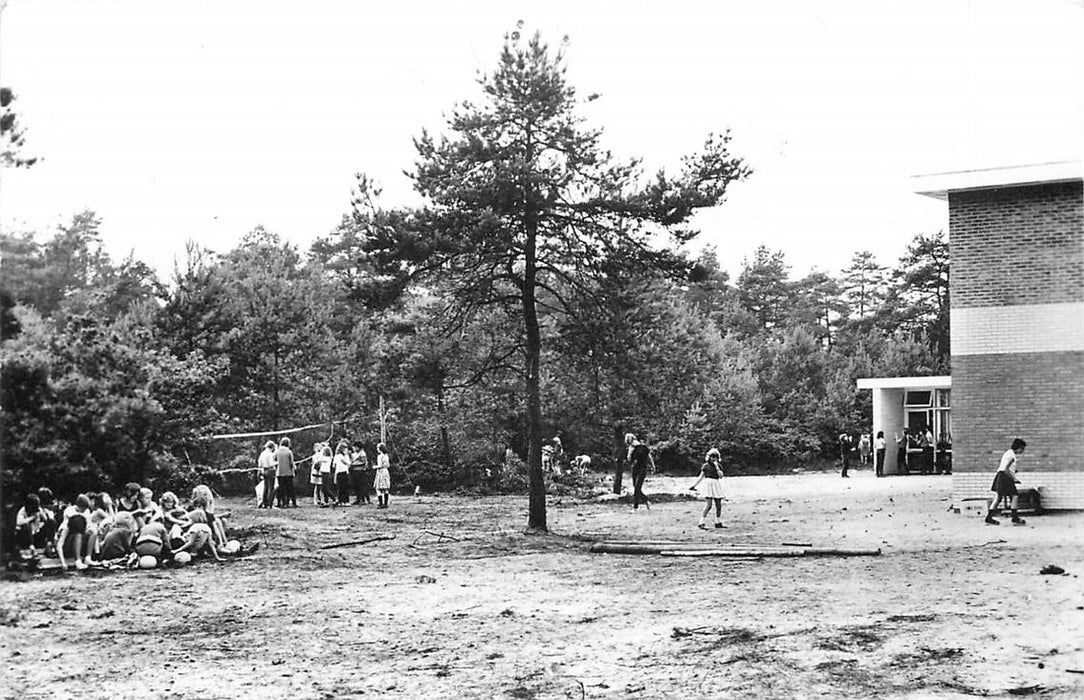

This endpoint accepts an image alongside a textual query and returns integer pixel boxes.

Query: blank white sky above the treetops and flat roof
[0,0,1084,277]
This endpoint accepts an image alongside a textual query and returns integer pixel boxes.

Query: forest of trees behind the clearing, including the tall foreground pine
[0,33,950,528]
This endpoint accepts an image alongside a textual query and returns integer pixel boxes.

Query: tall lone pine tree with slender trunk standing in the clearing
[351,33,748,530]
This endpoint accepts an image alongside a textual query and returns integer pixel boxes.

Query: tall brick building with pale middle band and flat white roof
[910,161,1084,508]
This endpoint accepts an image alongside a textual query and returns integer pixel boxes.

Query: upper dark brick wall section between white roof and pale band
[949,182,1084,308]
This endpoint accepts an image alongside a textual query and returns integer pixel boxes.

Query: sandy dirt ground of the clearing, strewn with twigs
[0,471,1084,700]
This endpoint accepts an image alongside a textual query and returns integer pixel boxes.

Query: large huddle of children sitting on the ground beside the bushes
[15,482,240,570]
